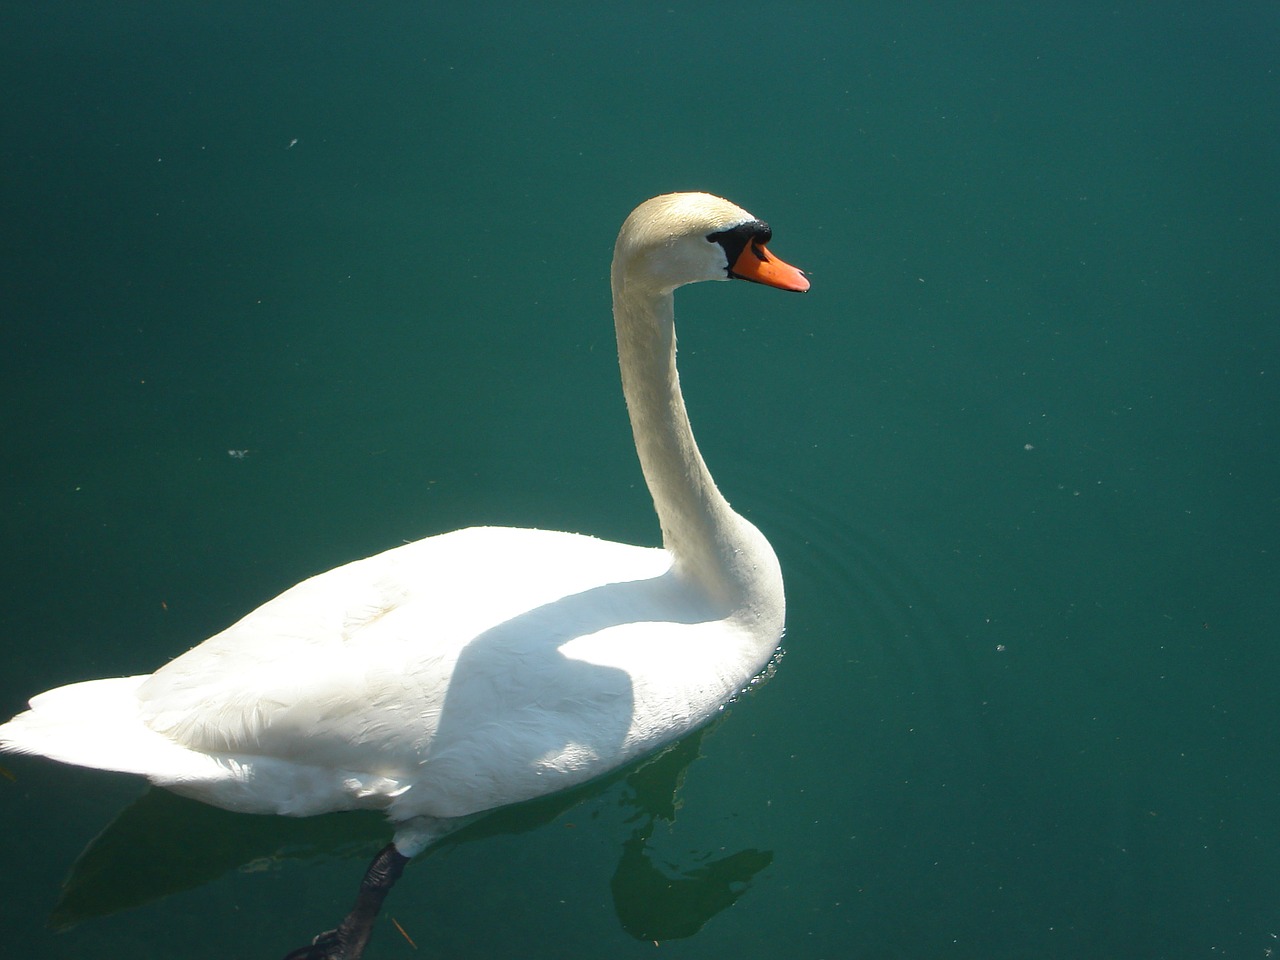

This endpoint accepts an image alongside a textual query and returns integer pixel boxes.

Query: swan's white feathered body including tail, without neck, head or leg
[15,527,762,831]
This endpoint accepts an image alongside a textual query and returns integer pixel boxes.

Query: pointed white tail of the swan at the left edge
[0,676,221,783]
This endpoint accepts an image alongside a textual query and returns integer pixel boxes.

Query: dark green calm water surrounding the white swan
[0,3,1280,960]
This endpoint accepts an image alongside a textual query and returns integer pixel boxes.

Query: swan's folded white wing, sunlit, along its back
[131,527,669,767]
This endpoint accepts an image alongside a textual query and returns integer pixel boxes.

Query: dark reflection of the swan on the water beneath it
[50,728,773,941]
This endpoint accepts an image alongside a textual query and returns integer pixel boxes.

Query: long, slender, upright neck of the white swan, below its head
[613,285,776,607]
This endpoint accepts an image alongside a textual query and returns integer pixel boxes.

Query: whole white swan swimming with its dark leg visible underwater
[0,193,809,960]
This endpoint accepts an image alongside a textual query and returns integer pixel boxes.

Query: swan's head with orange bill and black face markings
[613,193,809,293]
